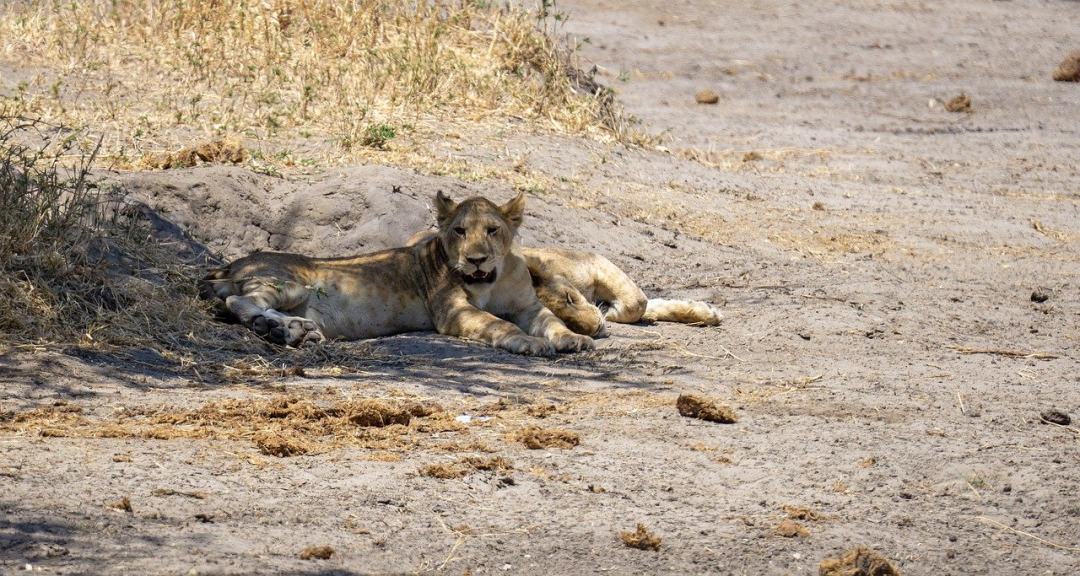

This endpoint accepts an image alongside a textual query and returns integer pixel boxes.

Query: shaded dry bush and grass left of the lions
[0,115,370,379]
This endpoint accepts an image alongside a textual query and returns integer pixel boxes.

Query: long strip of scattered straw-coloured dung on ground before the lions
[0,396,460,457]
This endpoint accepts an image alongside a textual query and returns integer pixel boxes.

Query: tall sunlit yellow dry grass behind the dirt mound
[0,0,632,168]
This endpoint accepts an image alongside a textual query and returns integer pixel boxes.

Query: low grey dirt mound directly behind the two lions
[117,165,612,259]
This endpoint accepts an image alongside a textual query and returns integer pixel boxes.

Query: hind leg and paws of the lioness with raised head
[225,280,325,346]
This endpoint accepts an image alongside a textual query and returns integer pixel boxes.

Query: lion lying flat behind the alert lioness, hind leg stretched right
[407,230,723,338]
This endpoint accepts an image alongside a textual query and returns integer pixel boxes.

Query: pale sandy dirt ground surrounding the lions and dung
[0,0,1080,575]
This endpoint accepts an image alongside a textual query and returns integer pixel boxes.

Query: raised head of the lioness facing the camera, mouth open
[435,190,525,284]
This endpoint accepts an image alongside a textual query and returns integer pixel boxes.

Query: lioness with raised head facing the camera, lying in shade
[203,191,593,356]
